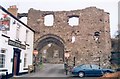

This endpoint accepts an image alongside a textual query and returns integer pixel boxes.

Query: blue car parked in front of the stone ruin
[71,64,114,77]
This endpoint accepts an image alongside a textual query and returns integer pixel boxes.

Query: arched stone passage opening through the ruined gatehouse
[37,37,64,63]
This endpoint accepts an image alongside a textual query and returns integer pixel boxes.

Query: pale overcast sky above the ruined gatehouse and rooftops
[0,0,119,37]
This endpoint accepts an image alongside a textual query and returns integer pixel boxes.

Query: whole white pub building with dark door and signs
[0,6,34,75]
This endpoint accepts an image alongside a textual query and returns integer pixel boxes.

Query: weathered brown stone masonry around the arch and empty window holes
[28,7,111,67]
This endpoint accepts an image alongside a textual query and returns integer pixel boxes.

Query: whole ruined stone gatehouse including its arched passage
[28,7,111,67]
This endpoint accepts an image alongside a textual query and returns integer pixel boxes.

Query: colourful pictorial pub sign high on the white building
[0,10,10,31]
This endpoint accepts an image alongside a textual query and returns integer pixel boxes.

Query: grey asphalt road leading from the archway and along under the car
[14,64,97,79]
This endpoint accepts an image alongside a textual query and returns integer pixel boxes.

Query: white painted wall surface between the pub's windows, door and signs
[0,9,34,73]
